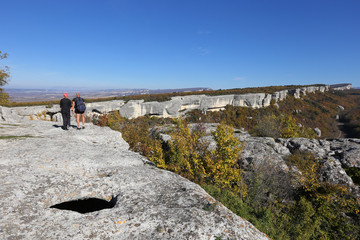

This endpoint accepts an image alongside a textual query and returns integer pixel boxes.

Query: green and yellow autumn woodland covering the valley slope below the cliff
[96,90,360,239]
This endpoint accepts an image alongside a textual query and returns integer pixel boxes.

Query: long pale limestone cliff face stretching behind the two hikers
[5,85,329,120]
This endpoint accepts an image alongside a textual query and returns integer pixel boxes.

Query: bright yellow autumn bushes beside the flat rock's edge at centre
[165,119,247,196]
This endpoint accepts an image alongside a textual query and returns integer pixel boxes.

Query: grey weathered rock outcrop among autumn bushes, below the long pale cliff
[157,124,360,197]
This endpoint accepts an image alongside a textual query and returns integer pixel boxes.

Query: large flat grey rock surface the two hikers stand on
[0,120,268,239]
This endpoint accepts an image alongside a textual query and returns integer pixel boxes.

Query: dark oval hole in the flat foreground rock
[50,195,119,213]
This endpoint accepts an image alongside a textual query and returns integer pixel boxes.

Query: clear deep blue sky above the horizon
[0,0,360,89]
